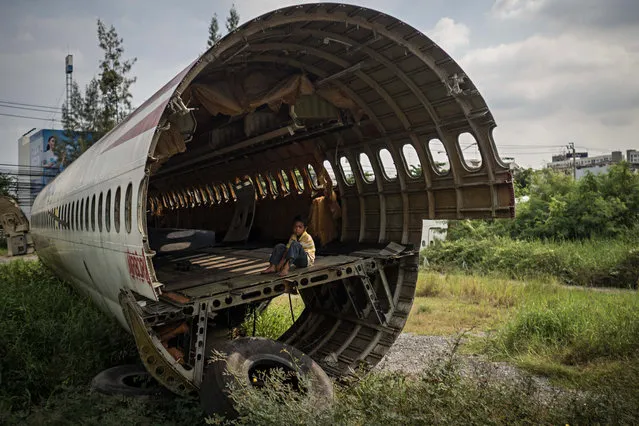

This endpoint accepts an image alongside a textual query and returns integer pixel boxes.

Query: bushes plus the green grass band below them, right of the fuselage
[422,163,639,288]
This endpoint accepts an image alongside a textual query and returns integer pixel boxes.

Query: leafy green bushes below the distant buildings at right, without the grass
[450,162,639,240]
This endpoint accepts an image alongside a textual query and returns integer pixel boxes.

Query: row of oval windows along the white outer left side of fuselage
[31,183,133,233]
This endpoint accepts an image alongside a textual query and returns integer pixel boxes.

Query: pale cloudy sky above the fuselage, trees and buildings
[0,0,639,167]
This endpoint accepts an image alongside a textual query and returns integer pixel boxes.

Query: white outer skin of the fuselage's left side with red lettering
[31,64,193,329]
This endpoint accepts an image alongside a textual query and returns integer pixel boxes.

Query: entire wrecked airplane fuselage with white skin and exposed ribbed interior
[31,4,514,416]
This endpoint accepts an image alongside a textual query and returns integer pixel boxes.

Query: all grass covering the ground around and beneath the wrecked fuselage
[0,260,639,425]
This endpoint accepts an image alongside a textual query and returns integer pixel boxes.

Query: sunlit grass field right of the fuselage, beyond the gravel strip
[405,271,639,423]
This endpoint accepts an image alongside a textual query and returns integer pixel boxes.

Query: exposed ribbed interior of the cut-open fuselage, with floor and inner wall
[135,4,514,396]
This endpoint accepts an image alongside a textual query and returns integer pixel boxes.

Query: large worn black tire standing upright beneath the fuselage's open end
[200,337,333,418]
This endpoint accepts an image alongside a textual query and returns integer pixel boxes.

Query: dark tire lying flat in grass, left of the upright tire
[91,364,164,396]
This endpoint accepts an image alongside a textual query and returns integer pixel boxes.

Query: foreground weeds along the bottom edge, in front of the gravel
[207,354,637,425]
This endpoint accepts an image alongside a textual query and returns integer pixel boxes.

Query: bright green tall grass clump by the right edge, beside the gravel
[495,291,639,365]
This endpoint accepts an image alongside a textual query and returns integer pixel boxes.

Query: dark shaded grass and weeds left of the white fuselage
[0,260,137,412]
